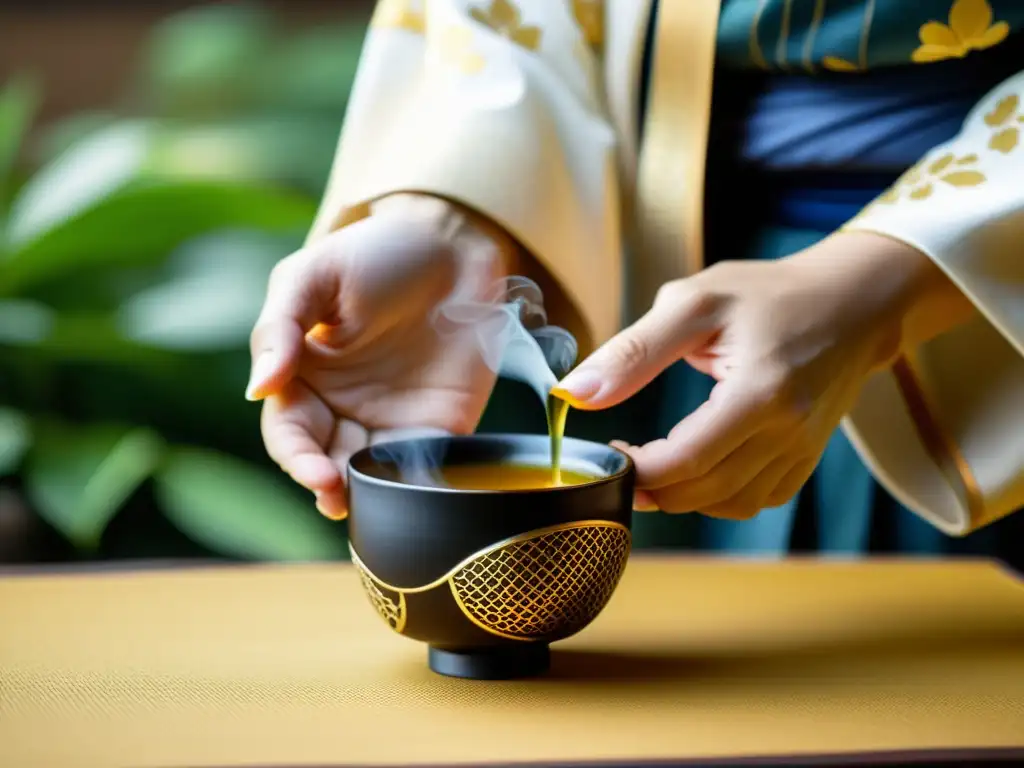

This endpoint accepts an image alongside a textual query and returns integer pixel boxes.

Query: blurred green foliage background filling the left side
[0,3,376,562]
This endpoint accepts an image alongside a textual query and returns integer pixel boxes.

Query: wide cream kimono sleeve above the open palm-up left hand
[311,0,622,343]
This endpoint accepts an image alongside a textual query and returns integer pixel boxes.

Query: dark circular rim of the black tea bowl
[345,432,636,496]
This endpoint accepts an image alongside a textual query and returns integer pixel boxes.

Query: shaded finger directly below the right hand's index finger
[644,432,784,512]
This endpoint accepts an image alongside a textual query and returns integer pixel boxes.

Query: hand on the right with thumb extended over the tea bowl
[556,233,958,519]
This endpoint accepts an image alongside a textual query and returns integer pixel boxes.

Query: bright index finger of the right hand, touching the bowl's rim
[630,380,781,489]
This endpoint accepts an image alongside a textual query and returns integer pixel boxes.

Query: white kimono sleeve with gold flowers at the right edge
[845,73,1024,536]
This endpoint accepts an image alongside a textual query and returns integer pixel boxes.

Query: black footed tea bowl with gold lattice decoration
[348,434,635,680]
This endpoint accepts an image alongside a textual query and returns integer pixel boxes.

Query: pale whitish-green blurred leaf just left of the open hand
[118,231,289,351]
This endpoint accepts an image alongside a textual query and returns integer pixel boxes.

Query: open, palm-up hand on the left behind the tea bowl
[246,196,504,519]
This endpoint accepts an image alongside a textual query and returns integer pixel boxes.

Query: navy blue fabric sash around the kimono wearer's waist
[640,0,1024,231]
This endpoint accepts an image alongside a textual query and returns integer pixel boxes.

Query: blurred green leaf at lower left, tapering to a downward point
[25,425,164,550]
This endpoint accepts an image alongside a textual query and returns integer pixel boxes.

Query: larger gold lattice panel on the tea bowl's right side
[449,521,632,640]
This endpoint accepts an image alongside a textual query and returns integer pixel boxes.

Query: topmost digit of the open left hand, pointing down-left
[246,240,343,400]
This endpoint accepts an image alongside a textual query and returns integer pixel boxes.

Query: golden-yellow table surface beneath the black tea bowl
[0,556,1024,768]
